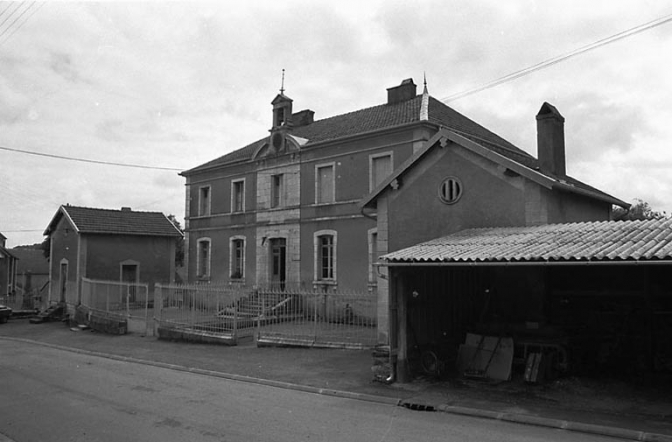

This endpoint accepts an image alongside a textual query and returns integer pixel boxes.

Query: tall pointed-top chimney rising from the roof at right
[537,102,566,178]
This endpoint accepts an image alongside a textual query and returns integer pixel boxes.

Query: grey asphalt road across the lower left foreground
[0,340,613,442]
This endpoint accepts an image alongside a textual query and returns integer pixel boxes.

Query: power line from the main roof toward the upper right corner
[441,14,672,103]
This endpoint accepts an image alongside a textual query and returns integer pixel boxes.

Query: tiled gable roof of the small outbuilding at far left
[44,205,182,237]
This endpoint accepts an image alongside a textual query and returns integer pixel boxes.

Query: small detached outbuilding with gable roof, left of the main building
[44,205,182,310]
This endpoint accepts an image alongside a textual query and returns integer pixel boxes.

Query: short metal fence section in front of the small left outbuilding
[80,278,154,335]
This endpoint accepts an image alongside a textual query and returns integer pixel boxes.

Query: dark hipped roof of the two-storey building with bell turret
[181,95,538,175]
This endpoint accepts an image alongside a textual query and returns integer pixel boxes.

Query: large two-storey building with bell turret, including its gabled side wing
[181,79,614,308]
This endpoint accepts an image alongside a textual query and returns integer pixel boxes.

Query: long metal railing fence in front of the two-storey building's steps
[155,284,377,348]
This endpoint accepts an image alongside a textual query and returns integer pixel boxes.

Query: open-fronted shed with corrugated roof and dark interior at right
[381,219,672,382]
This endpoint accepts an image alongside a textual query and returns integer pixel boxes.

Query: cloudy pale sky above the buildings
[0,0,672,247]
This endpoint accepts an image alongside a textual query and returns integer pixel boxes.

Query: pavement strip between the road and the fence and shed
[0,318,672,442]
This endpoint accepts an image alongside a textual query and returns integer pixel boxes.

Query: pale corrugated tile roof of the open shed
[381,219,672,265]
